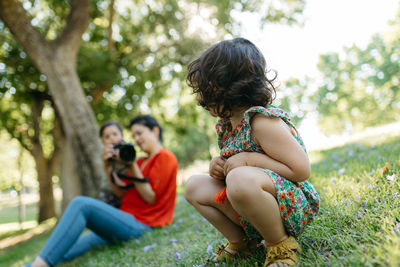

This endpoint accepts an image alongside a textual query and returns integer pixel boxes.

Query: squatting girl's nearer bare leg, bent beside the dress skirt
[226,166,288,245]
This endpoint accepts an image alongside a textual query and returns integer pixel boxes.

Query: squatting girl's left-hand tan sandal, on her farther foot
[212,237,259,262]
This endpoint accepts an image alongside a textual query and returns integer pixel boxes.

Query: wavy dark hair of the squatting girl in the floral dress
[186,38,277,118]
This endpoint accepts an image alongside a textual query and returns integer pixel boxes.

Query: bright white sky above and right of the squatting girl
[239,0,400,150]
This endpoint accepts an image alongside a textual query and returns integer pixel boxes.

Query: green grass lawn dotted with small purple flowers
[0,136,400,267]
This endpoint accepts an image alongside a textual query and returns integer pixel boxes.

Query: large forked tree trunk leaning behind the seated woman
[0,0,106,199]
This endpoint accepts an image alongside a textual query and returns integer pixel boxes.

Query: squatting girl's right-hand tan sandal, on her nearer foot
[264,236,301,267]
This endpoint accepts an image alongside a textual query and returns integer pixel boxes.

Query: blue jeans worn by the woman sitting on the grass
[40,196,152,266]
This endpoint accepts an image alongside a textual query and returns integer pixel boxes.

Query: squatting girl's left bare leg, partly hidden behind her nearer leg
[185,175,246,243]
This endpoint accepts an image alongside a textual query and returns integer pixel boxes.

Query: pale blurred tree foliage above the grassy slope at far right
[312,9,400,134]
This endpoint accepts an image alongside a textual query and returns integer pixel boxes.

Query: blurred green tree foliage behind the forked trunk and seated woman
[0,0,304,195]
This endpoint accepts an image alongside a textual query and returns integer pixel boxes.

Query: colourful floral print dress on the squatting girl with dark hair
[216,105,319,240]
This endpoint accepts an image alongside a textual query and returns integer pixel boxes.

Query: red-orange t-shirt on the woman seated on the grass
[120,149,178,227]
